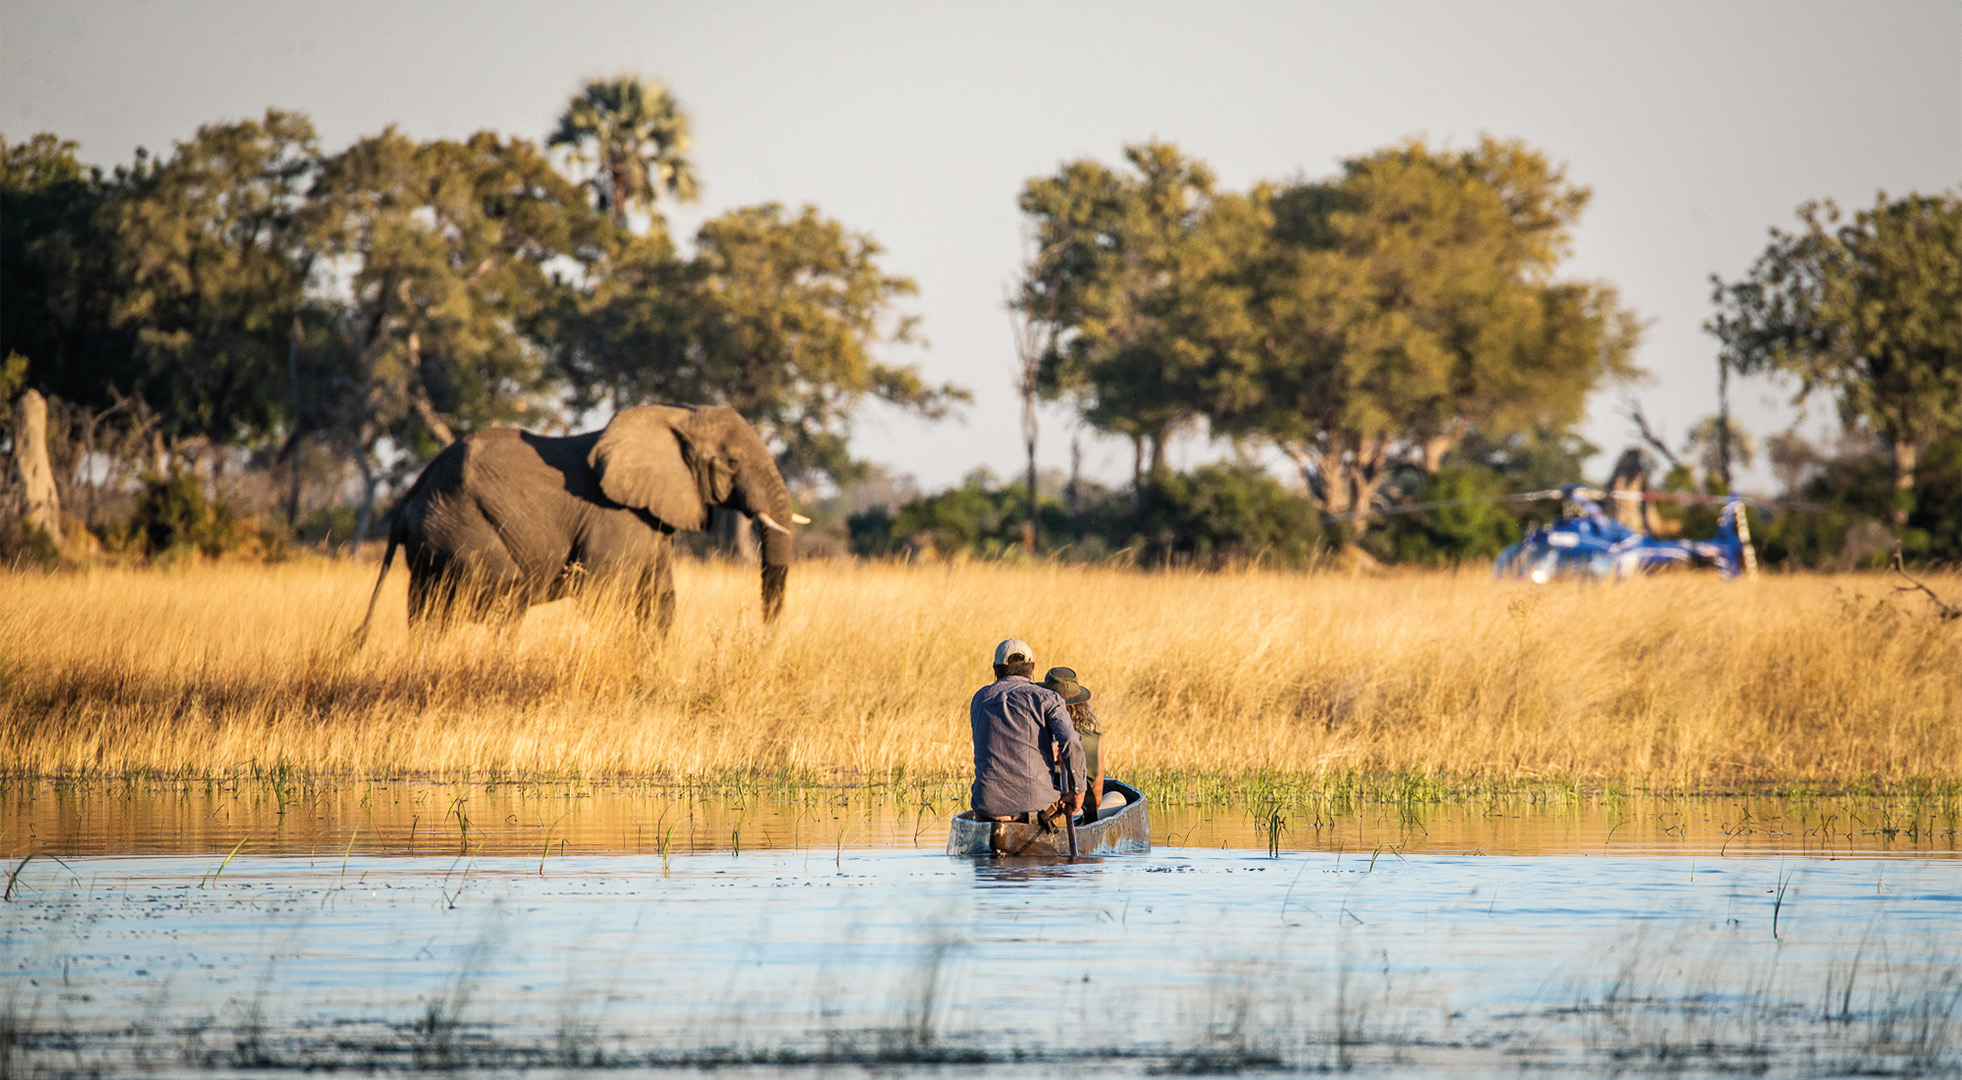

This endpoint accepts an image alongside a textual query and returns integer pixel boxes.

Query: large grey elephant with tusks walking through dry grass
[355,405,808,644]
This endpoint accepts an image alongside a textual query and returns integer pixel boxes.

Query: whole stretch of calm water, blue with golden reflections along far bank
[0,785,1962,1076]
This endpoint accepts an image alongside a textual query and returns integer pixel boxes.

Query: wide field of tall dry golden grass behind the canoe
[0,560,1962,789]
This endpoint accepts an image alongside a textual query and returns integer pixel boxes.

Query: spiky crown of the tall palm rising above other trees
[551,75,695,228]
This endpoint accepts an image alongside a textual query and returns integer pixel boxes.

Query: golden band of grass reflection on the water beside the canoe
[0,782,1962,860]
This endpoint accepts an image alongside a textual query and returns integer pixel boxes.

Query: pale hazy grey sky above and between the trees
[0,0,1962,489]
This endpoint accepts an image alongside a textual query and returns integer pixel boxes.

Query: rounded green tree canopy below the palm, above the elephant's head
[559,202,969,481]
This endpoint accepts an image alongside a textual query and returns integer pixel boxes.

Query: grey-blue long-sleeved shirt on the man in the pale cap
[967,675,1085,817]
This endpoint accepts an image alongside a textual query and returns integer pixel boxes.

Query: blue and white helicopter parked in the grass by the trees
[1493,483,1758,585]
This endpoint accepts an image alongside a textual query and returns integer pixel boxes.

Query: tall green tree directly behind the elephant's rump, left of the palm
[310,128,608,542]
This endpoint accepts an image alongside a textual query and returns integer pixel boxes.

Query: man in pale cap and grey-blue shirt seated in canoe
[967,638,1087,829]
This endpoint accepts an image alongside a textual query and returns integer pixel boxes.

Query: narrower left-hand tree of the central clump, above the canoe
[1018,143,1264,479]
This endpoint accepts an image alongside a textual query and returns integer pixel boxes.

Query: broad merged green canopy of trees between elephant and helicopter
[1018,137,1640,534]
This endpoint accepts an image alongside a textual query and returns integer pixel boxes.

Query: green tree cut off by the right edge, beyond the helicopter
[1705,192,1962,528]
